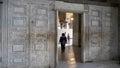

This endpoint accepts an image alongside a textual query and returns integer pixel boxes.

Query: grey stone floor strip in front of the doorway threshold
[57,61,120,68]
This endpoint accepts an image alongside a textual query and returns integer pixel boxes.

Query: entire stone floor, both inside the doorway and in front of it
[57,46,120,68]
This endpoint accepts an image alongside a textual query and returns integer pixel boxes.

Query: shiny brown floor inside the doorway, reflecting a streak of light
[58,46,81,62]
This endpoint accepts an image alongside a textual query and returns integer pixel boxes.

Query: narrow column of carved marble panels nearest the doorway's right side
[89,6,101,51]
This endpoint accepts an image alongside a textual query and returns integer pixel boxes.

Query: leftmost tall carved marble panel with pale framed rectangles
[8,3,29,68]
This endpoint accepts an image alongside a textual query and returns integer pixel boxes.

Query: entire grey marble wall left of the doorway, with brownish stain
[0,0,56,68]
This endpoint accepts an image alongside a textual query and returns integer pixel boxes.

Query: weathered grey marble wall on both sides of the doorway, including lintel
[0,0,118,68]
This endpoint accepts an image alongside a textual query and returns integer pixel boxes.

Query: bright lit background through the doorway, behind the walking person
[57,11,73,47]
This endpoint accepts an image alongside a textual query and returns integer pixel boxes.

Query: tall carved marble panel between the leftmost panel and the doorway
[30,5,49,67]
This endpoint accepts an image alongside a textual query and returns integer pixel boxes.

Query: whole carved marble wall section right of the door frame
[89,5,117,61]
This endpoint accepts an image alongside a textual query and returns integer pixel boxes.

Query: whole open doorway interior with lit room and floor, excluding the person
[57,11,82,63]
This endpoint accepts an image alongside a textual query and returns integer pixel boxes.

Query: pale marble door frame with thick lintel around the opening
[55,1,86,65]
